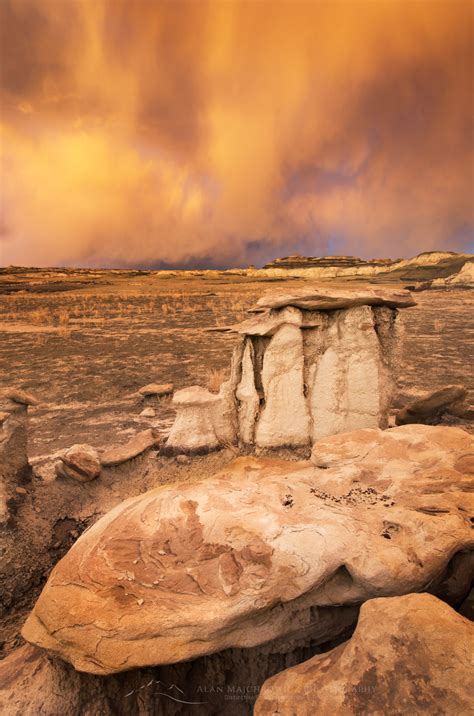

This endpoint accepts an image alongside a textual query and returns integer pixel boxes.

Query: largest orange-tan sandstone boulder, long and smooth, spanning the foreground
[23,425,473,673]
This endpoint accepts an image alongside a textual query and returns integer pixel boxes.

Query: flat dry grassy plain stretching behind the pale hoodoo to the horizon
[0,254,474,457]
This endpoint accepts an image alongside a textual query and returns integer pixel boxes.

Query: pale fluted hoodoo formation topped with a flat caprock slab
[167,287,415,452]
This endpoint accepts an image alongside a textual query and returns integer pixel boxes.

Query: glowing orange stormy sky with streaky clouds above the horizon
[0,0,474,268]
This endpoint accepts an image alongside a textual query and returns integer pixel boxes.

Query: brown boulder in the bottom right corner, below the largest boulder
[254,594,474,716]
